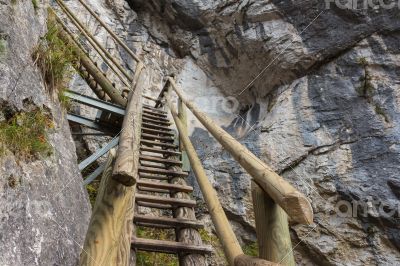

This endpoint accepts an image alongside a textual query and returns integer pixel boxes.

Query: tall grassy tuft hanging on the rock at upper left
[32,19,75,102]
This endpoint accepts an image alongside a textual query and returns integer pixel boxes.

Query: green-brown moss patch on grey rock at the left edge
[0,110,53,158]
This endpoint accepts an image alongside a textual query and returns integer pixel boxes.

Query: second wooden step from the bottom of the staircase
[133,215,204,229]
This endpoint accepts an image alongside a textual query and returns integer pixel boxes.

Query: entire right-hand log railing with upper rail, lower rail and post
[156,78,313,266]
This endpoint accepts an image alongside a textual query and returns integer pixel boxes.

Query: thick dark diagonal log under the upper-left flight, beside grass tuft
[57,22,127,106]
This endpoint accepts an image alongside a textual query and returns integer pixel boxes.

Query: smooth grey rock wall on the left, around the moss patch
[0,0,91,265]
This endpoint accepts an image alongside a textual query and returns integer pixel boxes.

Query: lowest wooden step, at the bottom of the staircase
[131,237,213,254]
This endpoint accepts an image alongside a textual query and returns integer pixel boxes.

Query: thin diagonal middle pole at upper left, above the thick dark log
[56,0,133,82]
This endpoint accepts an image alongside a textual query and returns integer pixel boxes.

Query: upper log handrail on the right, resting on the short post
[169,78,313,224]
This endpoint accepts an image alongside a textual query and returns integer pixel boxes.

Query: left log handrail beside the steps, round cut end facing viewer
[113,69,148,186]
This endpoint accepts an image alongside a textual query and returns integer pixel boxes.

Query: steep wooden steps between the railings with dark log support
[131,105,212,265]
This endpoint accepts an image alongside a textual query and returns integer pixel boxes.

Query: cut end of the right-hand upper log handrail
[284,193,314,225]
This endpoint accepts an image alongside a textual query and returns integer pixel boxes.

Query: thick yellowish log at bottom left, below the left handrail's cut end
[79,150,136,266]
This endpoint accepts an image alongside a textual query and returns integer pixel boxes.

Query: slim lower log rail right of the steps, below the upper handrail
[165,92,277,265]
